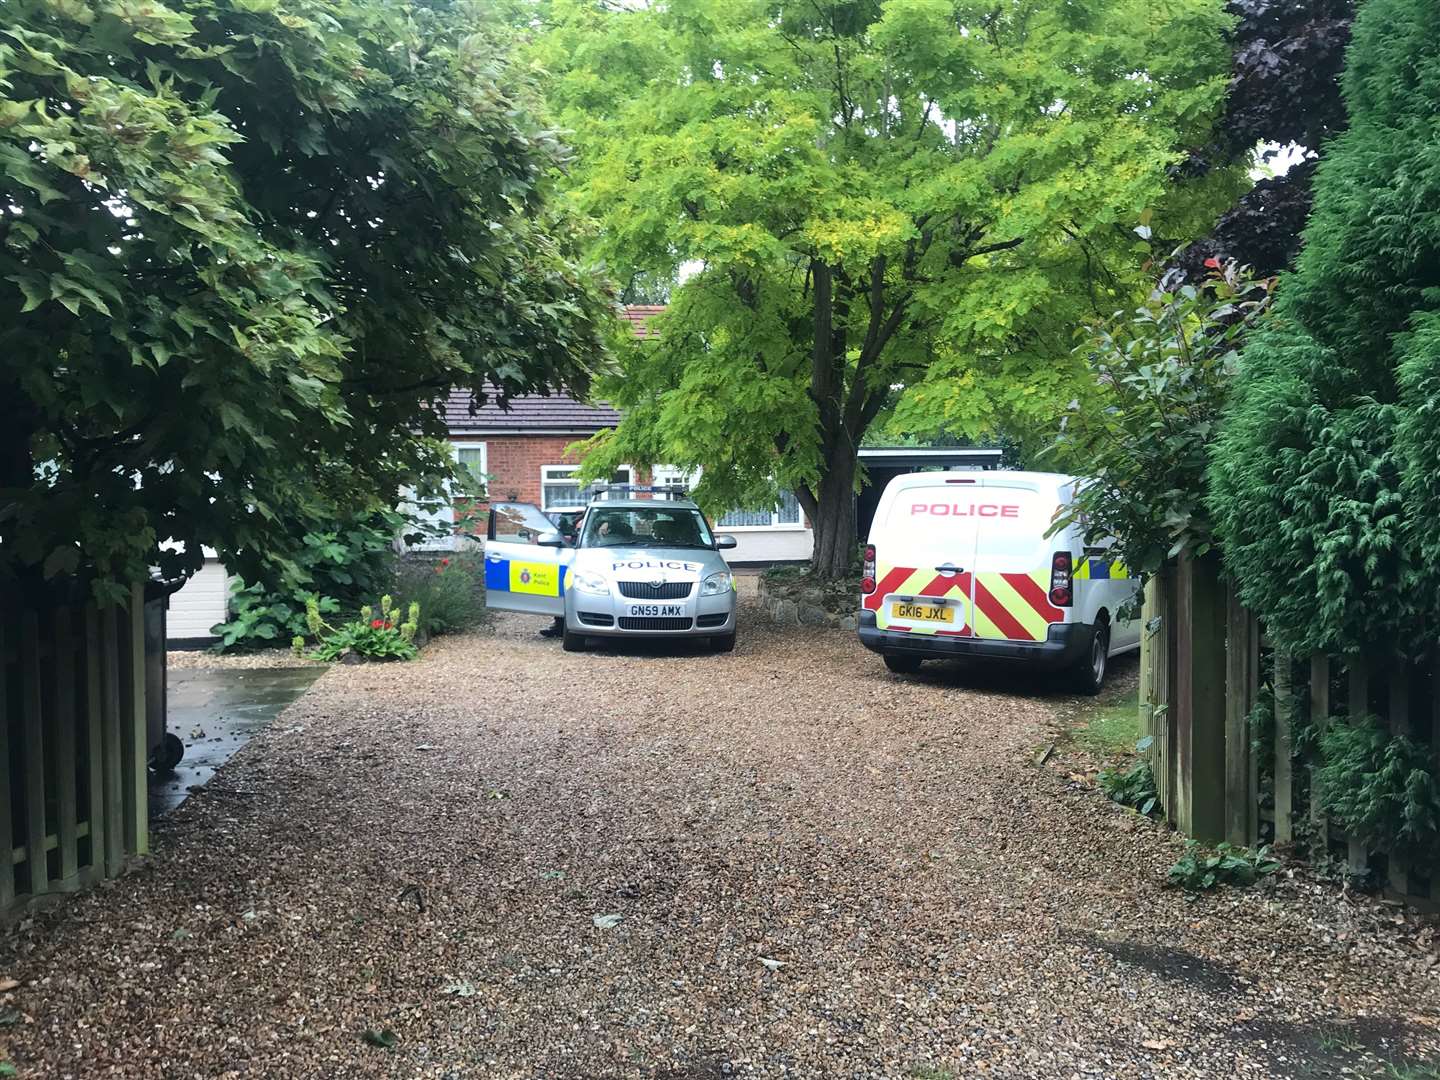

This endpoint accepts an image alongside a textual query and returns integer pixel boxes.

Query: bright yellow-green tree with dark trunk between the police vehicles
[536,0,1238,575]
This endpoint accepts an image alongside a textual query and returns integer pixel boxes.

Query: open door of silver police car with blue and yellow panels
[485,503,575,615]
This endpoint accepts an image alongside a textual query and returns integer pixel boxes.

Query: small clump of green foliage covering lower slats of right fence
[1318,717,1440,870]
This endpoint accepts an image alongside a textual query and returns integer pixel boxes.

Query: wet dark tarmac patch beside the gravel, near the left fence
[150,664,325,818]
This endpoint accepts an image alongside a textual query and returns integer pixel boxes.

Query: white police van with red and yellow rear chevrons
[860,471,1140,694]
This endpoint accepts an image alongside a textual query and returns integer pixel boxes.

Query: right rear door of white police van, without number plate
[972,474,1067,641]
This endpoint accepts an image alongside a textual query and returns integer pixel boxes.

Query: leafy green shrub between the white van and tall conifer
[1051,264,1272,576]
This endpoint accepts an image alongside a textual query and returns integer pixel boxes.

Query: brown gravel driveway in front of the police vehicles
[0,608,1440,1080]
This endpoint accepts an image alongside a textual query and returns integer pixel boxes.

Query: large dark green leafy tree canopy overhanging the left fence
[0,0,612,595]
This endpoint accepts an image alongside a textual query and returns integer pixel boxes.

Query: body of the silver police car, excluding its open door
[558,492,736,652]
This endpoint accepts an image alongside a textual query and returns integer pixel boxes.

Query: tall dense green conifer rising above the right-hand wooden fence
[1210,0,1440,655]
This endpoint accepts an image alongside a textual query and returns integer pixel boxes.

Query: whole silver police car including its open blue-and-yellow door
[485,485,736,652]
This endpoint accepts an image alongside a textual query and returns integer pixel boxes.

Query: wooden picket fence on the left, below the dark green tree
[0,586,154,916]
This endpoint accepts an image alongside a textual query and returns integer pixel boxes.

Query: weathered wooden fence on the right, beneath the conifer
[1140,557,1440,907]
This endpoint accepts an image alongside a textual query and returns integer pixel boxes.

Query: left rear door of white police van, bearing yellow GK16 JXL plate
[863,472,978,636]
